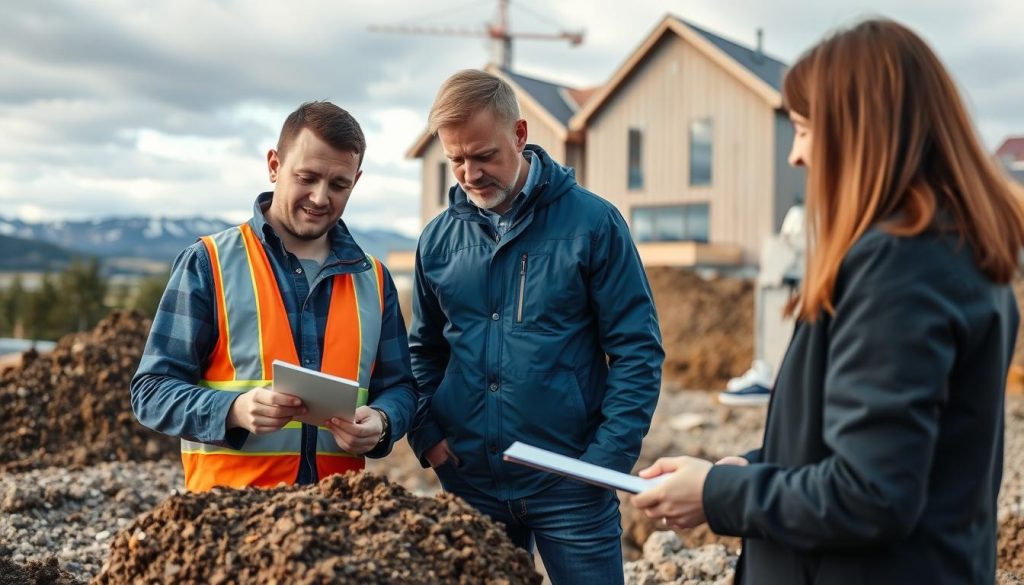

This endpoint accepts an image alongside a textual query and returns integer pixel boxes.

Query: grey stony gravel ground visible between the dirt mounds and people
[0,391,1024,585]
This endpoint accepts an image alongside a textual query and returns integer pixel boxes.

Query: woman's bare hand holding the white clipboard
[630,457,712,529]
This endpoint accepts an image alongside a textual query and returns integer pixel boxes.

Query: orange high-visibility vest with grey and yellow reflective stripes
[181,223,384,491]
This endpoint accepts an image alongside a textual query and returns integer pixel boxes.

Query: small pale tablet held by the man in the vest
[272,360,359,426]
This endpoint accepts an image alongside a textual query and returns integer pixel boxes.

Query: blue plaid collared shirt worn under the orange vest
[131,193,416,484]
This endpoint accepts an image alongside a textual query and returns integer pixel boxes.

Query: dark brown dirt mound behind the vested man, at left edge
[0,311,178,471]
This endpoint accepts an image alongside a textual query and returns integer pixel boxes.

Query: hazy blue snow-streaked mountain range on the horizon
[0,216,416,271]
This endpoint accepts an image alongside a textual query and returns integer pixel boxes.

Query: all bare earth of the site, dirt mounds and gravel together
[0,278,1024,585]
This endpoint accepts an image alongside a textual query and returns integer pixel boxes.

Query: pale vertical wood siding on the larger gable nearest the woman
[586,33,775,264]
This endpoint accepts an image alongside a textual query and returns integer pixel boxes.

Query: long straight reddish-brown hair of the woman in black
[782,19,1024,321]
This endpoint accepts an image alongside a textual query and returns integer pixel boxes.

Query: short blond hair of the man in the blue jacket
[427,69,519,134]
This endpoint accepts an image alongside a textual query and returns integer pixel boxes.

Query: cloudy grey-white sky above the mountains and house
[0,0,1024,236]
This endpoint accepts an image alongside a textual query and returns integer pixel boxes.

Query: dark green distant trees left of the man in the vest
[0,258,168,340]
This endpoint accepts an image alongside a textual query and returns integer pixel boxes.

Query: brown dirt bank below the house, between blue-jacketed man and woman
[647,267,754,389]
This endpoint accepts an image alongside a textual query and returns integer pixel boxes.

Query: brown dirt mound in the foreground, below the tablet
[93,472,541,585]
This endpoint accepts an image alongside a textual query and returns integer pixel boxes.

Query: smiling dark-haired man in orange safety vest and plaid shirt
[131,101,416,491]
